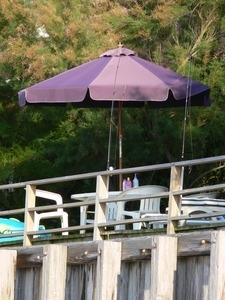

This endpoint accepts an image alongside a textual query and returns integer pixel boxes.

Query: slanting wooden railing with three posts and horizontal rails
[0,155,225,246]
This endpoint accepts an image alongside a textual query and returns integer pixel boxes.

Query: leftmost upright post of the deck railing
[23,185,36,246]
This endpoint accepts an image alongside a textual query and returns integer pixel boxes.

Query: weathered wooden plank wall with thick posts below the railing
[0,228,225,300]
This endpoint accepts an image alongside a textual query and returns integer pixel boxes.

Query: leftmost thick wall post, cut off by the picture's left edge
[0,250,17,300]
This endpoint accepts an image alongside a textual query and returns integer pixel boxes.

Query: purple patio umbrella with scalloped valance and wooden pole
[19,47,210,189]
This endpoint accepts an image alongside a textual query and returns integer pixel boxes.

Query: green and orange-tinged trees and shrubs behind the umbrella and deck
[0,0,225,214]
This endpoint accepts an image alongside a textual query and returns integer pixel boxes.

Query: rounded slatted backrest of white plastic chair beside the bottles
[120,185,168,213]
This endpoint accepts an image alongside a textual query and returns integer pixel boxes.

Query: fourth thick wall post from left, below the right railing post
[149,236,177,300]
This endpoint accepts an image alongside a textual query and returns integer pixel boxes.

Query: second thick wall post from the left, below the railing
[40,245,67,300]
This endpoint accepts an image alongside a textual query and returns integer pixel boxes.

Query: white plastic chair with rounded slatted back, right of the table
[117,185,168,230]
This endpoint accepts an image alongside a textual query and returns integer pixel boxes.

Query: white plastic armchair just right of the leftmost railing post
[34,189,68,235]
